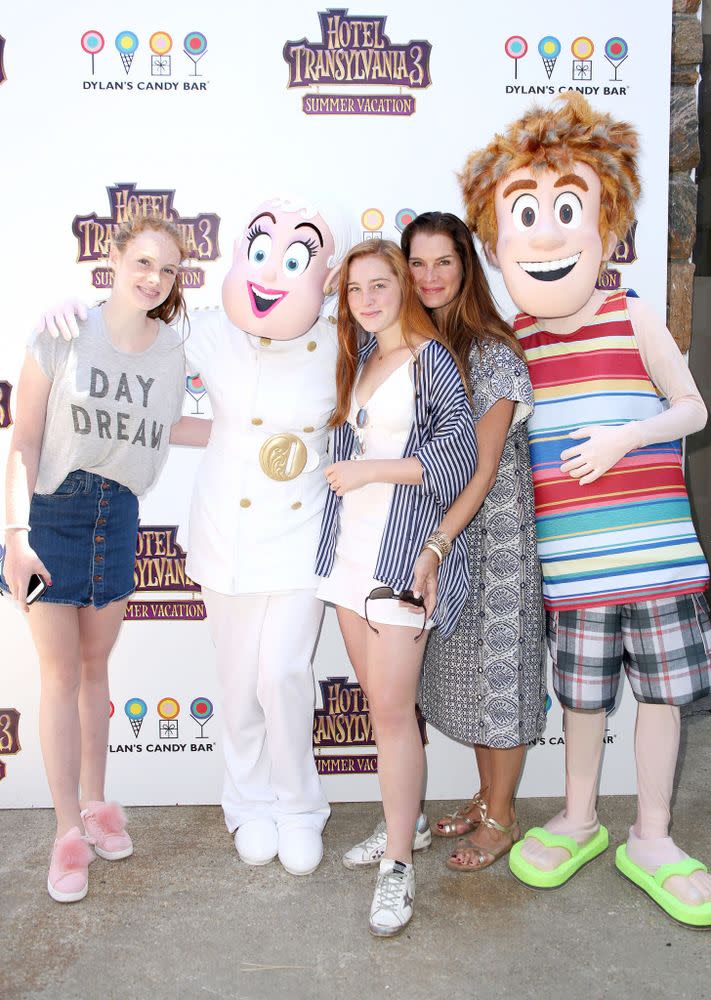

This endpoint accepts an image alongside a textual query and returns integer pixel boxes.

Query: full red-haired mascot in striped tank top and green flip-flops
[460,94,711,927]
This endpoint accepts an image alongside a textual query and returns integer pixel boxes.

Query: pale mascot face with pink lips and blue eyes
[222,198,335,340]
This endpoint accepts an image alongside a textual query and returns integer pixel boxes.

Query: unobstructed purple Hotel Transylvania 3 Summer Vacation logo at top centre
[283,8,432,116]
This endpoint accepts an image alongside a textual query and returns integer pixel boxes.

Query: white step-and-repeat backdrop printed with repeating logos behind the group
[0,0,671,807]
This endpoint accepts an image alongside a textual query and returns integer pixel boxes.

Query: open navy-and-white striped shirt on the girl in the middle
[316,337,477,639]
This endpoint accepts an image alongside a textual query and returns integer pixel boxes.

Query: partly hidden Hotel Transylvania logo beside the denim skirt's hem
[124,525,205,620]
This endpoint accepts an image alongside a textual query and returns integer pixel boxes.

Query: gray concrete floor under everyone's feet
[0,713,711,1000]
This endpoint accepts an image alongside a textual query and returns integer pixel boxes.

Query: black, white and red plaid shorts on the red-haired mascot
[547,594,711,711]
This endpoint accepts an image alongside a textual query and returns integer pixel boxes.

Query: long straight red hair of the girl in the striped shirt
[329,240,467,427]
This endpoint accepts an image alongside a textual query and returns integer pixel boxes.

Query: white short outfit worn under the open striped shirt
[317,358,432,630]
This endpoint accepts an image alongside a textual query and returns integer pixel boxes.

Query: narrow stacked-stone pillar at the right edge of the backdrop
[667,0,703,352]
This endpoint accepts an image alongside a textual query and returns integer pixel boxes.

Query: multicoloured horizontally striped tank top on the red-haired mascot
[514,289,709,611]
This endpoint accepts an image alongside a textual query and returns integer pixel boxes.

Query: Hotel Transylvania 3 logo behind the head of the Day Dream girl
[72,184,220,288]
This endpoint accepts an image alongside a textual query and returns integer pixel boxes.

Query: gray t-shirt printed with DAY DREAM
[27,306,185,496]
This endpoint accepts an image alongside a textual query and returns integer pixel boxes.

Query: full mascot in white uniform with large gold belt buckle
[185,198,350,875]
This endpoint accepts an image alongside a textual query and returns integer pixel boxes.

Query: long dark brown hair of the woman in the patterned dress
[400,212,523,371]
